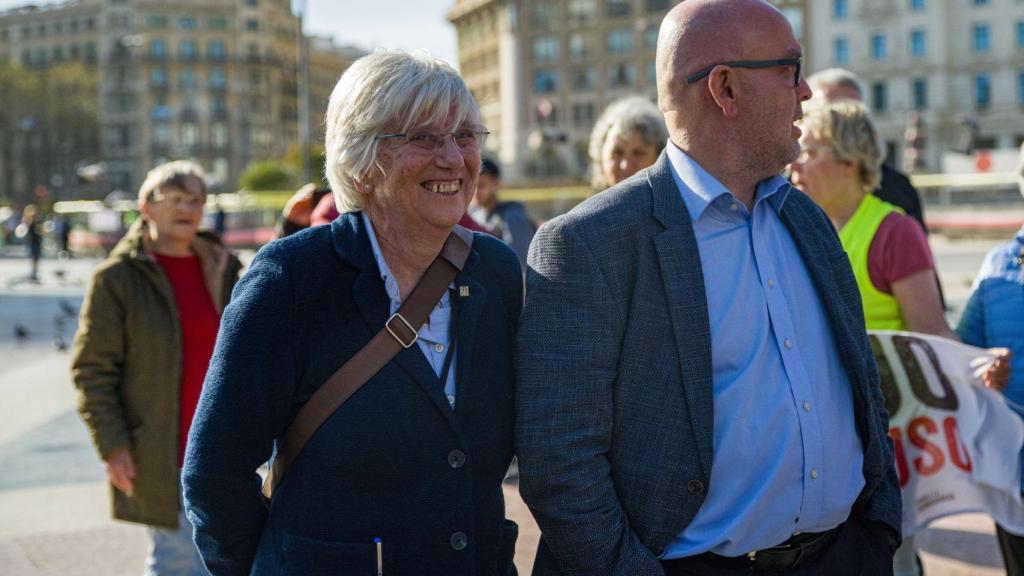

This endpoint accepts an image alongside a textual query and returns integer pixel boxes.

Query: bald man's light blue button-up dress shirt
[663,140,864,559]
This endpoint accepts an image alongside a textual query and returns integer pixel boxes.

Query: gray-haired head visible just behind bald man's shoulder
[589,96,669,192]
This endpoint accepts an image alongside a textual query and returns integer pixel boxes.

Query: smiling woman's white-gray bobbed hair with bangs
[324,51,480,213]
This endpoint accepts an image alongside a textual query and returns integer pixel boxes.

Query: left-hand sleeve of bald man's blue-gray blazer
[516,220,663,576]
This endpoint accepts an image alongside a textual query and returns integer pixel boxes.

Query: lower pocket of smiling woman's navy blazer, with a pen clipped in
[283,534,394,576]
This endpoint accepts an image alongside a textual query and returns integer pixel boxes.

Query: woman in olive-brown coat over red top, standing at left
[72,162,242,575]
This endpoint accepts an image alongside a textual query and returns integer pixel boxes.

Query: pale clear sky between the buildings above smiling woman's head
[0,0,458,66]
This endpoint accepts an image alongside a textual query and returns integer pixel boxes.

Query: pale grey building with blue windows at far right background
[805,0,1024,172]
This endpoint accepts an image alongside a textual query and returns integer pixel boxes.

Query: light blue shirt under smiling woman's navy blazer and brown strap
[362,212,457,410]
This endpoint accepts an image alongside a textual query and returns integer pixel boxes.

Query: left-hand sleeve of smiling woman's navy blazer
[182,246,297,576]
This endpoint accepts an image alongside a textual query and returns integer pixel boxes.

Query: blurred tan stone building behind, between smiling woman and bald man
[447,0,809,182]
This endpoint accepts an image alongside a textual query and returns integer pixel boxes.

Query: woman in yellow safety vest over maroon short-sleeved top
[792,100,957,339]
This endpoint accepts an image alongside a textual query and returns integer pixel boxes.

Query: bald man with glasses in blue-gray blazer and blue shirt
[516,0,901,576]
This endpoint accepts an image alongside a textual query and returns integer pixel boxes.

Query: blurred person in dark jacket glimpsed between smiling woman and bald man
[473,158,537,270]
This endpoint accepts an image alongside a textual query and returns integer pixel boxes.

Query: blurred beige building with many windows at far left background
[0,0,311,199]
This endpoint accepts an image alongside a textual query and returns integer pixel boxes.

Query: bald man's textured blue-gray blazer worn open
[516,153,901,576]
